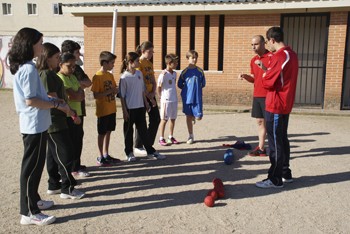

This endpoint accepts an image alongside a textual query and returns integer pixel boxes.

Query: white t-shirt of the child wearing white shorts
[158,69,177,102]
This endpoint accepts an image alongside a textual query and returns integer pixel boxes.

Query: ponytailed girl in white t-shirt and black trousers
[119,52,165,162]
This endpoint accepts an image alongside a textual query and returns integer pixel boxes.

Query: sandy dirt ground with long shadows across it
[0,91,350,233]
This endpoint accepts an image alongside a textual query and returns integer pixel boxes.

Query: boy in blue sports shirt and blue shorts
[177,50,205,144]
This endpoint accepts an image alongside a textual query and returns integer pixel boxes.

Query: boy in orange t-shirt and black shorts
[91,51,121,167]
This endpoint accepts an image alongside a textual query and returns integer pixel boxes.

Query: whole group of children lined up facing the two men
[8,28,205,225]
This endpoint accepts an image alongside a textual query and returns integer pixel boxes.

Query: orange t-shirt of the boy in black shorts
[91,71,117,117]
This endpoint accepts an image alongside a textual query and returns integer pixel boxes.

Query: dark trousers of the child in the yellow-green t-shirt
[67,116,84,171]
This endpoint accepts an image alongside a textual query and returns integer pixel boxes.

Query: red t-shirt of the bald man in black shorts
[250,50,273,97]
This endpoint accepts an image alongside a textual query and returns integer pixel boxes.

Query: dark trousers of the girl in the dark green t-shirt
[46,129,77,194]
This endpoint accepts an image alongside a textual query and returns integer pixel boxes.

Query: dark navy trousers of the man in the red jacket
[265,111,292,185]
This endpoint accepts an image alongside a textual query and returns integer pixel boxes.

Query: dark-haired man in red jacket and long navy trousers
[255,27,299,188]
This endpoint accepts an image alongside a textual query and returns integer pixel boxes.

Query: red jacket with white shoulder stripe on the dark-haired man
[262,46,299,115]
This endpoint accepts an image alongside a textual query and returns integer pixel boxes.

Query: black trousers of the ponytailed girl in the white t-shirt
[123,107,156,155]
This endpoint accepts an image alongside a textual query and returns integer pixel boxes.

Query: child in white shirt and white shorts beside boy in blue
[157,54,179,146]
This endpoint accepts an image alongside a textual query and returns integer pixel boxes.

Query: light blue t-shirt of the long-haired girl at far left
[13,61,51,134]
